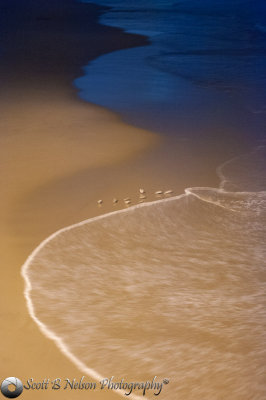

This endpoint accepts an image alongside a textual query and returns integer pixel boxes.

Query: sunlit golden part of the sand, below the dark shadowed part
[0,90,158,399]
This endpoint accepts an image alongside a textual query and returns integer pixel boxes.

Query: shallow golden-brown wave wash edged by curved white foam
[23,146,266,400]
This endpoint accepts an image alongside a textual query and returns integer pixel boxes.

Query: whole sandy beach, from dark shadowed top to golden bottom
[0,0,243,399]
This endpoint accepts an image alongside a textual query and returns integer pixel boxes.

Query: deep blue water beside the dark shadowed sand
[75,0,266,141]
